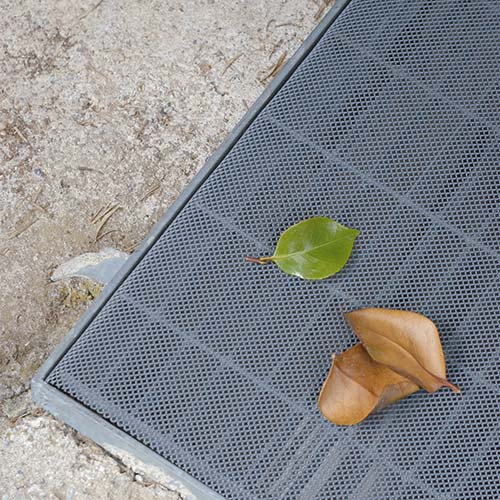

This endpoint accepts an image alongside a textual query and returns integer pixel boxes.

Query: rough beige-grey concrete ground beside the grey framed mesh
[0,0,331,500]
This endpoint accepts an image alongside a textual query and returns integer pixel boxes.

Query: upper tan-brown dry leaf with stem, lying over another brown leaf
[345,308,460,393]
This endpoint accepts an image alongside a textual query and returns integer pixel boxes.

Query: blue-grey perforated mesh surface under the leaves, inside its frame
[48,0,500,500]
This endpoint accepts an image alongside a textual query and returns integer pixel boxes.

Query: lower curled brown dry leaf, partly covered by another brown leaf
[318,344,419,425]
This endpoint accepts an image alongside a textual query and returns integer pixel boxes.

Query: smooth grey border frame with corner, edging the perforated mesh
[31,0,349,500]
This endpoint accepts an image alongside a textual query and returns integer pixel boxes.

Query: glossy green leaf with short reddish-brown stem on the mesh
[247,217,359,280]
